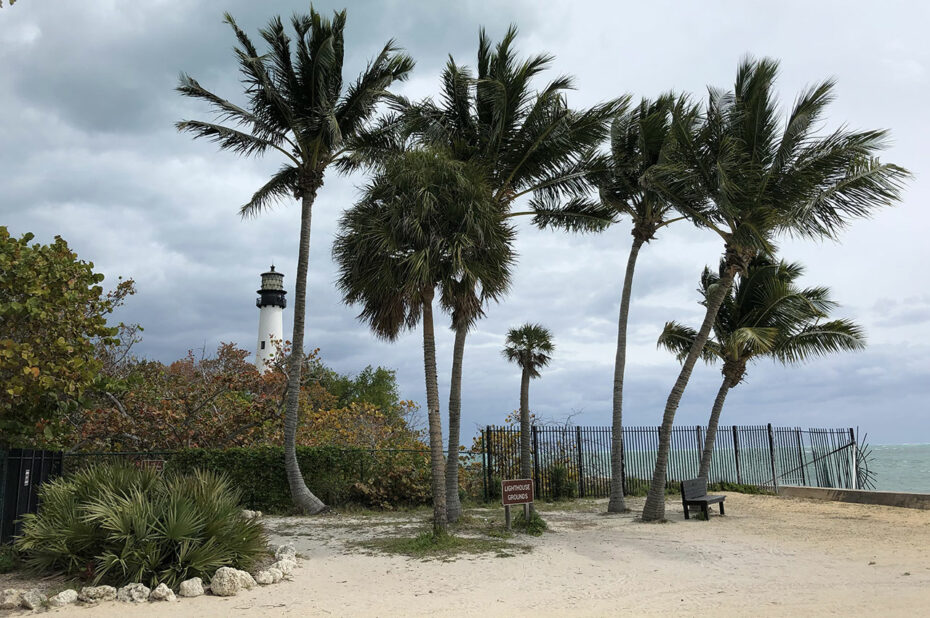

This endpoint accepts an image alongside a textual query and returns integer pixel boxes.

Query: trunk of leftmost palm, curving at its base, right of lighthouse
[284,184,326,515]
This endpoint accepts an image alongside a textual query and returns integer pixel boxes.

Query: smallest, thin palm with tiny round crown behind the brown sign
[503,324,555,508]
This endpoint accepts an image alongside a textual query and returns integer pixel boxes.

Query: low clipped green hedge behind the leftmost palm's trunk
[166,447,430,513]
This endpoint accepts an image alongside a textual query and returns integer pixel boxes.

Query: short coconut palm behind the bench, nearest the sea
[659,258,865,480]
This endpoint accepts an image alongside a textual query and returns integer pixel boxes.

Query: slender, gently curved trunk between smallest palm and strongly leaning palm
[607,236,644,513]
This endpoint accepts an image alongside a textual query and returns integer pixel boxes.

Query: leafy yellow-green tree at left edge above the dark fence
[0,226,132,444]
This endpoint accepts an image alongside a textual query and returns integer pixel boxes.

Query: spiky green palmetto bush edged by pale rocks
[15,464,266,587]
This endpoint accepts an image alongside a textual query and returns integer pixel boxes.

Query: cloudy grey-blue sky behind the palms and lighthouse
[0,0,930,444]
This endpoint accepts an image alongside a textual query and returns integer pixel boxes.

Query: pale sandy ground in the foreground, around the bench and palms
[7,494,930,618]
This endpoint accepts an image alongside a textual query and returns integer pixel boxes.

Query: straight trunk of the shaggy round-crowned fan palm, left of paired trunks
[423,290,446,535]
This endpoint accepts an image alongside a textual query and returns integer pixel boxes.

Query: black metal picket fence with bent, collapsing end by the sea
[482,424,865,498]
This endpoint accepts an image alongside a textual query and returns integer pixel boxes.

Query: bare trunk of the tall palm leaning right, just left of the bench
[643,266,735,521]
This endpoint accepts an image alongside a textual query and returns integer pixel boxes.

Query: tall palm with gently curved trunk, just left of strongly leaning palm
[594,94,696,513]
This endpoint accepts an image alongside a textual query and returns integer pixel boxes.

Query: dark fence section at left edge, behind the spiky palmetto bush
[0,448,62,543]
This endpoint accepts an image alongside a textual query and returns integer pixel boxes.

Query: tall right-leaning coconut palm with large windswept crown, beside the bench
[643,58,907,521]
